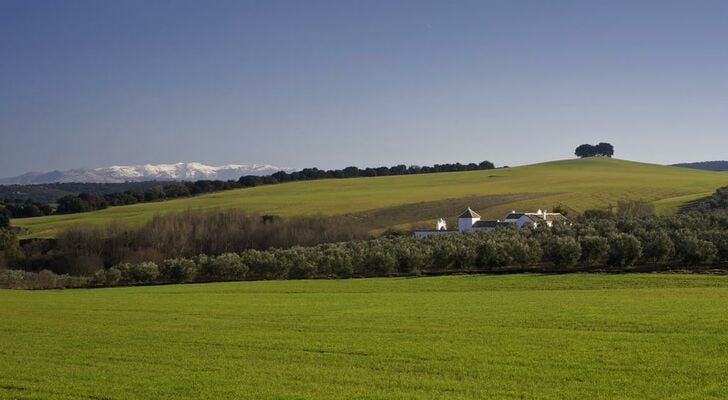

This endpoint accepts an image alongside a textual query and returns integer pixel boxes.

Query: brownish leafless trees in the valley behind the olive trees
[2,209,371,275]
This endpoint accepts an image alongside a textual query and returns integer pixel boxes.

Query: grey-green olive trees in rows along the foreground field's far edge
[5,209,728,285]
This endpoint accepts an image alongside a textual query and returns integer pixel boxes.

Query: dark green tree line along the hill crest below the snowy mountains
[0,161,495,218]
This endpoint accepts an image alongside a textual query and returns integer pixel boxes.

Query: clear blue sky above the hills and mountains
[0,0,728,176]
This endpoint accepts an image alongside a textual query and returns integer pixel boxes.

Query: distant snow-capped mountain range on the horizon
[0,162,293,185]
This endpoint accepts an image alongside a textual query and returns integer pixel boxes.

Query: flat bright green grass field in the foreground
[0,274,728,399]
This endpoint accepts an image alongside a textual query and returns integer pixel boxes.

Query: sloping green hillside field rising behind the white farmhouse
[13,158,728,237]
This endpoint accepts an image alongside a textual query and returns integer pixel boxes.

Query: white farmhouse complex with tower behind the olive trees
[415,207,567,237]
